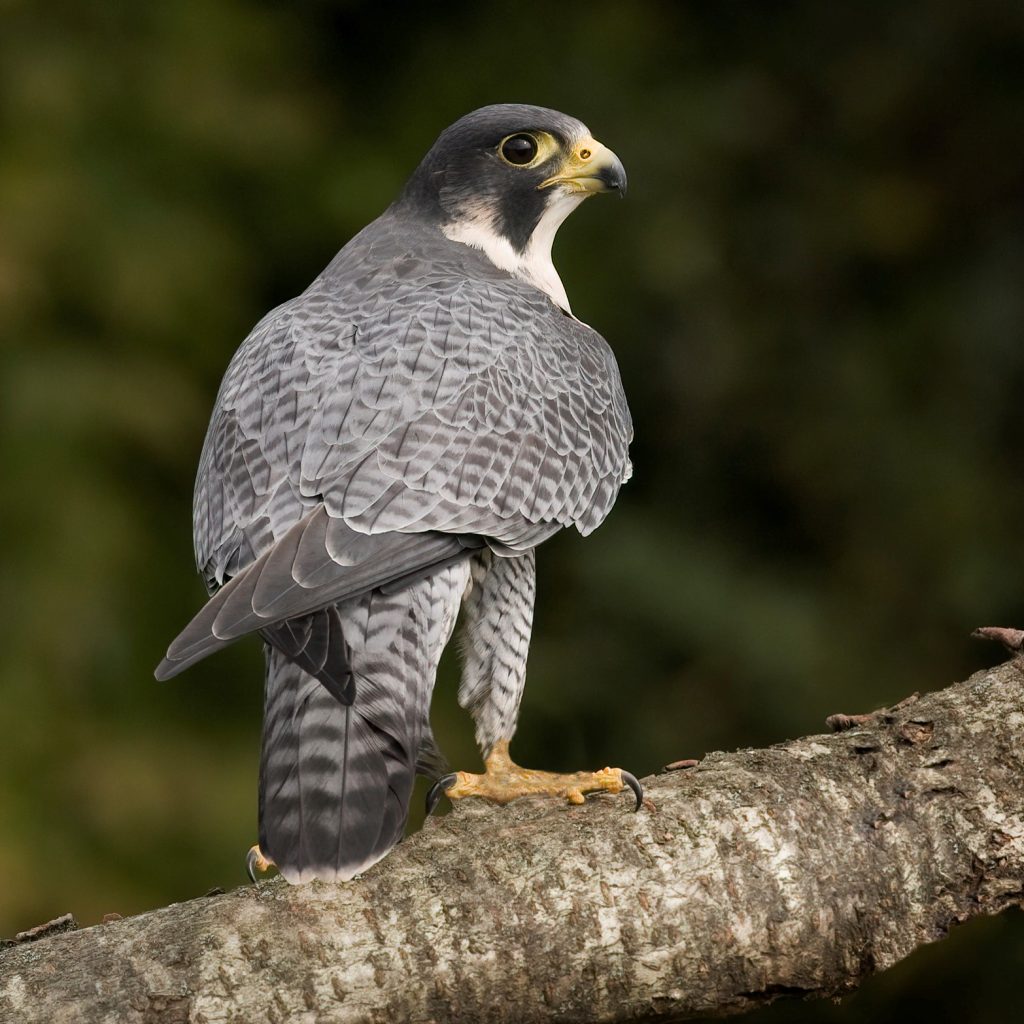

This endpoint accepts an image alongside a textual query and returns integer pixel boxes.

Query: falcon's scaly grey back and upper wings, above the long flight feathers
[188,213,632,585]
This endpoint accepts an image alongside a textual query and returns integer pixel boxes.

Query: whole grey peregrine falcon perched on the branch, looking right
[156,104,641,883]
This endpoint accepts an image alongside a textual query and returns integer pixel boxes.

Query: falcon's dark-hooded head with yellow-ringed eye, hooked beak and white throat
[396,103,626,311]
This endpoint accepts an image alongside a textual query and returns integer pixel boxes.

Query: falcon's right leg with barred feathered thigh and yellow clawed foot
[427,551,643,813]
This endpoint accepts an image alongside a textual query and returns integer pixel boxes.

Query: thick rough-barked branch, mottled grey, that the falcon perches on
[0,658,1024,1024]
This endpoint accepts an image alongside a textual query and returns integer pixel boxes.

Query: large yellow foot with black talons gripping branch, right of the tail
[427,739,643,814]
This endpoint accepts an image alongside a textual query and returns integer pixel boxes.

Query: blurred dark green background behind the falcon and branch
[0,0,1024,1022]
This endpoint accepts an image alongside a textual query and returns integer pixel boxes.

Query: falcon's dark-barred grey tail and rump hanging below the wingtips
[260,559,469,882]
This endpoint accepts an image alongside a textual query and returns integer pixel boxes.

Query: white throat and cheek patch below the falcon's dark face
[442,189,587,314]
